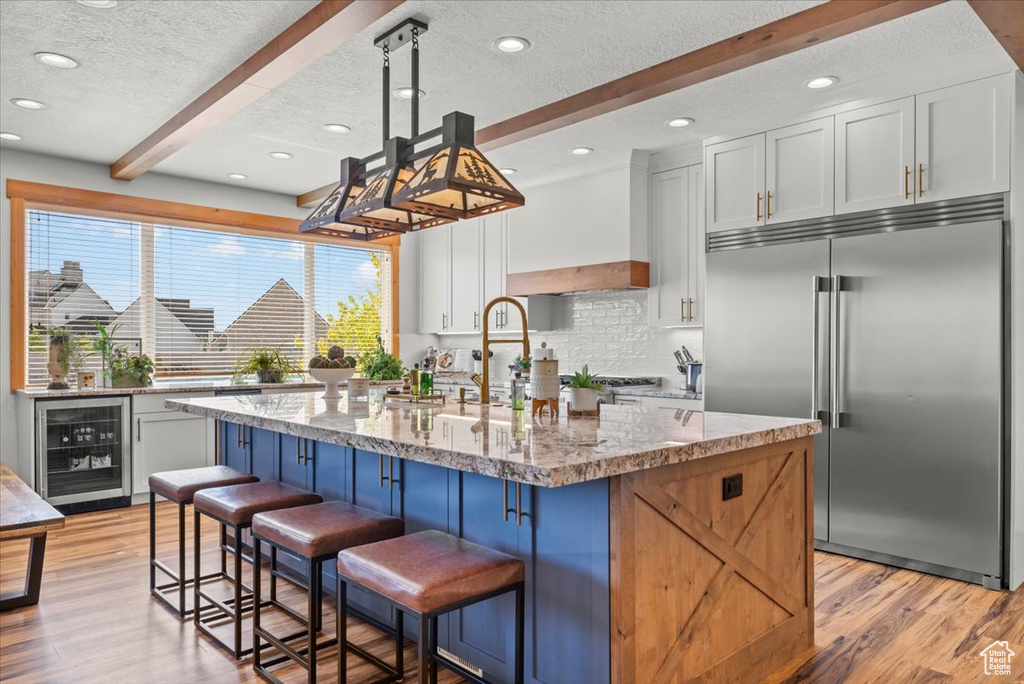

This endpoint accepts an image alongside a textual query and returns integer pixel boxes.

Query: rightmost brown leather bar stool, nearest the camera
[338,530,525,684]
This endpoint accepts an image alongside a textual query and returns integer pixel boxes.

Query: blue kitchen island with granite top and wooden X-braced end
[167,390,819,684]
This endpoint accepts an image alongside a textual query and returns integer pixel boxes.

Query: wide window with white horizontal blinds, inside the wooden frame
[27,211,391,386]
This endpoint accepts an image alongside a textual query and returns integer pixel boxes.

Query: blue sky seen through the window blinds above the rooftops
[29,212,375,330]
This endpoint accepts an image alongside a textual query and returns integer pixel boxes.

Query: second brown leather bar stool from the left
[193,482,324,658]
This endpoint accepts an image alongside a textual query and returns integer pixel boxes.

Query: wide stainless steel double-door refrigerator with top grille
[705,195,1008,588]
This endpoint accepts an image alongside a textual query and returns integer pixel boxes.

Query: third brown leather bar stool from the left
[252,501,406,684]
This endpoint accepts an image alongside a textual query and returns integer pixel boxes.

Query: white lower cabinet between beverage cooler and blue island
[131,394,216,495]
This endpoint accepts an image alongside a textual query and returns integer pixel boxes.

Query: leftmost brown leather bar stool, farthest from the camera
[150,466,259,619]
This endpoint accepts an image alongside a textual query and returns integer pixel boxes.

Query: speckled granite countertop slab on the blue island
[166,389,821,487]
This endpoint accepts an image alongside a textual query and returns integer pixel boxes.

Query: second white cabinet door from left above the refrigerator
[764,117,835,224]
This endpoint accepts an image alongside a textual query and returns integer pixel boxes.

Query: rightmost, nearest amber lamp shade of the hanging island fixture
[391,142,525,219]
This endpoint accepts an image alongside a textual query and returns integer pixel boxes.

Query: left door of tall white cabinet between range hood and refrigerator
[648,168,689,327]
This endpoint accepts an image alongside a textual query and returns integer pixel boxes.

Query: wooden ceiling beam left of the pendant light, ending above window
[111,0,404,180]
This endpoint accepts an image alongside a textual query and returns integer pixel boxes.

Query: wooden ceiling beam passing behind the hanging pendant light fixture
[296,0,937,207]
